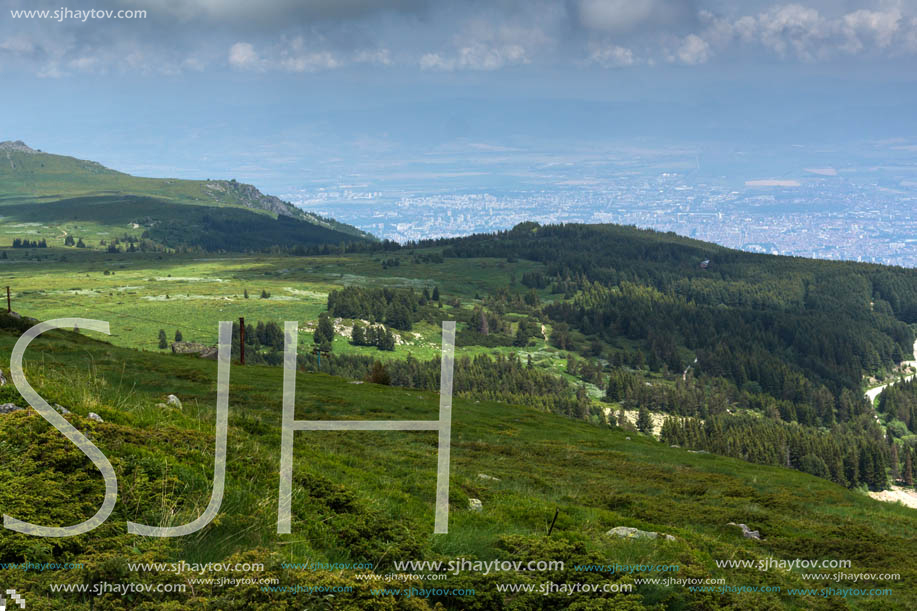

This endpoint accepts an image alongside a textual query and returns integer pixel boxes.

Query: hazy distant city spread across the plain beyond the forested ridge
[285,168,917,267]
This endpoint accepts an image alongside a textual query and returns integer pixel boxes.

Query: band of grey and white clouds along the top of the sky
[0,0,917,76]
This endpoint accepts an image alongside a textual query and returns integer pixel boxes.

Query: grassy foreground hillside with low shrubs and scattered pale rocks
[0,316,917,609]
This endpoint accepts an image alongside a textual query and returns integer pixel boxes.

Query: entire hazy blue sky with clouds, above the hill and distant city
[0,0,917,192]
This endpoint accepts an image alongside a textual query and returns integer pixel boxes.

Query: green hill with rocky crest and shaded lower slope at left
[0,141,374,250]
